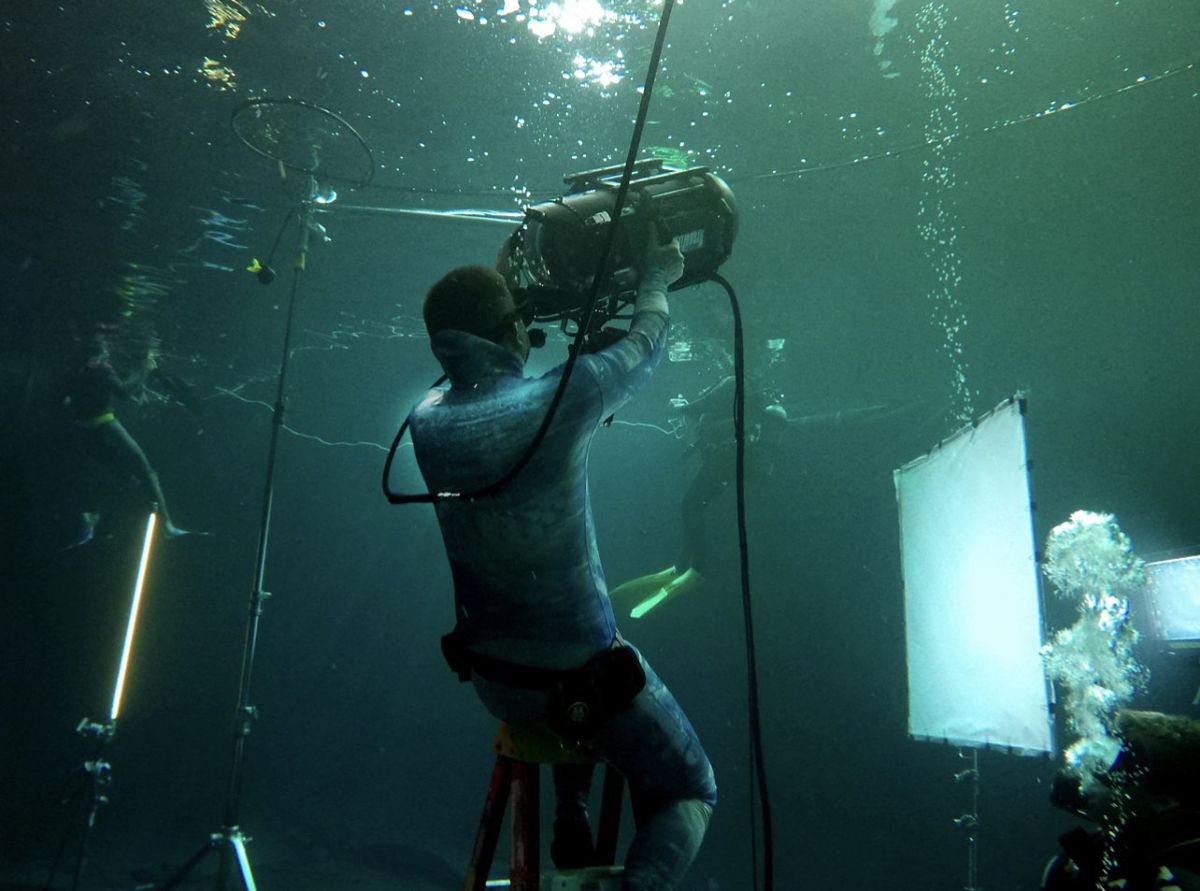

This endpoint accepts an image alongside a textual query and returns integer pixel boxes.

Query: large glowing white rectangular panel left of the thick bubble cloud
[894,400,1052,754]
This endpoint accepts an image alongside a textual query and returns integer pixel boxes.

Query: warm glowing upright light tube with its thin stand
[46,513,158,889]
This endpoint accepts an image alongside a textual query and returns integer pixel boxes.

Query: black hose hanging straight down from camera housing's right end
[712,274,775,891]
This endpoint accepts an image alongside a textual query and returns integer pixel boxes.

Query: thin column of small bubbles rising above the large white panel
[917,0,974,424]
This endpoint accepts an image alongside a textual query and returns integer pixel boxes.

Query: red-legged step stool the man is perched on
[463,722,625,891]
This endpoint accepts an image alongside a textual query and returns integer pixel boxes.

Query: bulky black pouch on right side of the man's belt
[548,644,646,742]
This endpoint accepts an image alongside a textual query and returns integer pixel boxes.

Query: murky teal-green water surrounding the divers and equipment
[0,0,1200,891]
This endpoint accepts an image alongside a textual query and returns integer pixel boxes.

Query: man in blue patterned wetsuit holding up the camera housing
[410,231,716,891]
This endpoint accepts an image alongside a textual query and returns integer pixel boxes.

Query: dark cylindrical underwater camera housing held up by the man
[497,159,738,327]
